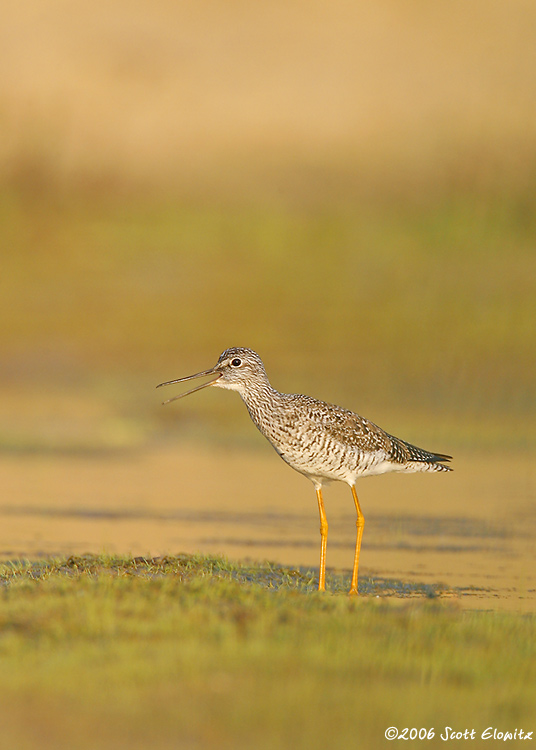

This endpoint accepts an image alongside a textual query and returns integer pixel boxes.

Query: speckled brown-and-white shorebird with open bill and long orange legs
[157,347,452,594]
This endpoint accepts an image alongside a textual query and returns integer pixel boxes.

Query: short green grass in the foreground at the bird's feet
[0,556,536,750]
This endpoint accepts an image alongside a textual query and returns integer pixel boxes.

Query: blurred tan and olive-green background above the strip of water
[0,0,536,452]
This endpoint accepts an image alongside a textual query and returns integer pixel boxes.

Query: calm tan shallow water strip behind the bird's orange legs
[0,443,536,611]
